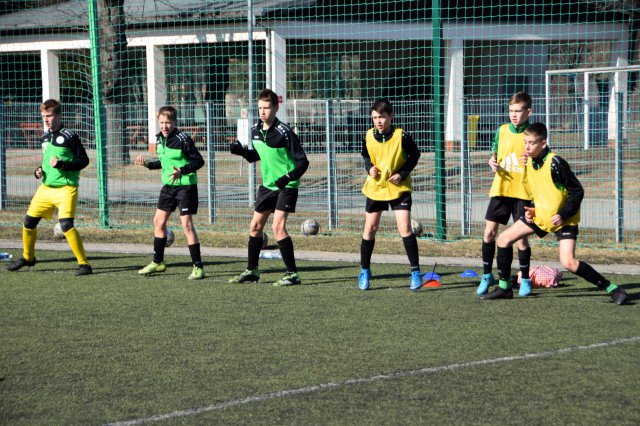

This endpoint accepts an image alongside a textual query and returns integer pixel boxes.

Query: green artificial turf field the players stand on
[0,251,640,425]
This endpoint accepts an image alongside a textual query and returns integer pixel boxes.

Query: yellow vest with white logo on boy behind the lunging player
[489,124,531,200]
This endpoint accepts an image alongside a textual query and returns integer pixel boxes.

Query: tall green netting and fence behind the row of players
[0,0,640,244]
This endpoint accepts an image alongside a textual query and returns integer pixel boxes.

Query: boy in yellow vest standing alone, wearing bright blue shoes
[358,99,422,291]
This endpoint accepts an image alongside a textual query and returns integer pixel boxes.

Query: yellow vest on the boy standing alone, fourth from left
[362,129,411,201]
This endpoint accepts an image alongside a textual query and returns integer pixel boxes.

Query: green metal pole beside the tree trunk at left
[89,0,110,228]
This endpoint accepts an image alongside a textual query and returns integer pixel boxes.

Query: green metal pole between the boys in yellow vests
[431,0,453,240]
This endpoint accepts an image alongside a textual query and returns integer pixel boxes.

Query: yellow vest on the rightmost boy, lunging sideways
[527,153,580,232]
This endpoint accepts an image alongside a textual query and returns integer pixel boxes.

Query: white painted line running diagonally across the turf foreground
[105,336,640,426]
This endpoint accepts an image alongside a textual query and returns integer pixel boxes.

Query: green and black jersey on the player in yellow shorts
[40,126,89,188]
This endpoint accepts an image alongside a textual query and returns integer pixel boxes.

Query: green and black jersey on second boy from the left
[146,128,204,186]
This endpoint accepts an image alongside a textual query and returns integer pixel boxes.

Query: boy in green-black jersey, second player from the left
[135,106,205,280]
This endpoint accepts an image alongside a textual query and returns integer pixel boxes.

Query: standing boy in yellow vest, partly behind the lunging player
[476,92,531,297]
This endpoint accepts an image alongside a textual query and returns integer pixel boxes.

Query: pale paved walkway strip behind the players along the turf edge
[0,239,640,275]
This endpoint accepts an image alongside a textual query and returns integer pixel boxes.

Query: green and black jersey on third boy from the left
[245,118,309,191]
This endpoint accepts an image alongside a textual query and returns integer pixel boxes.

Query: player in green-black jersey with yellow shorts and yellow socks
[7,99,93,275]
